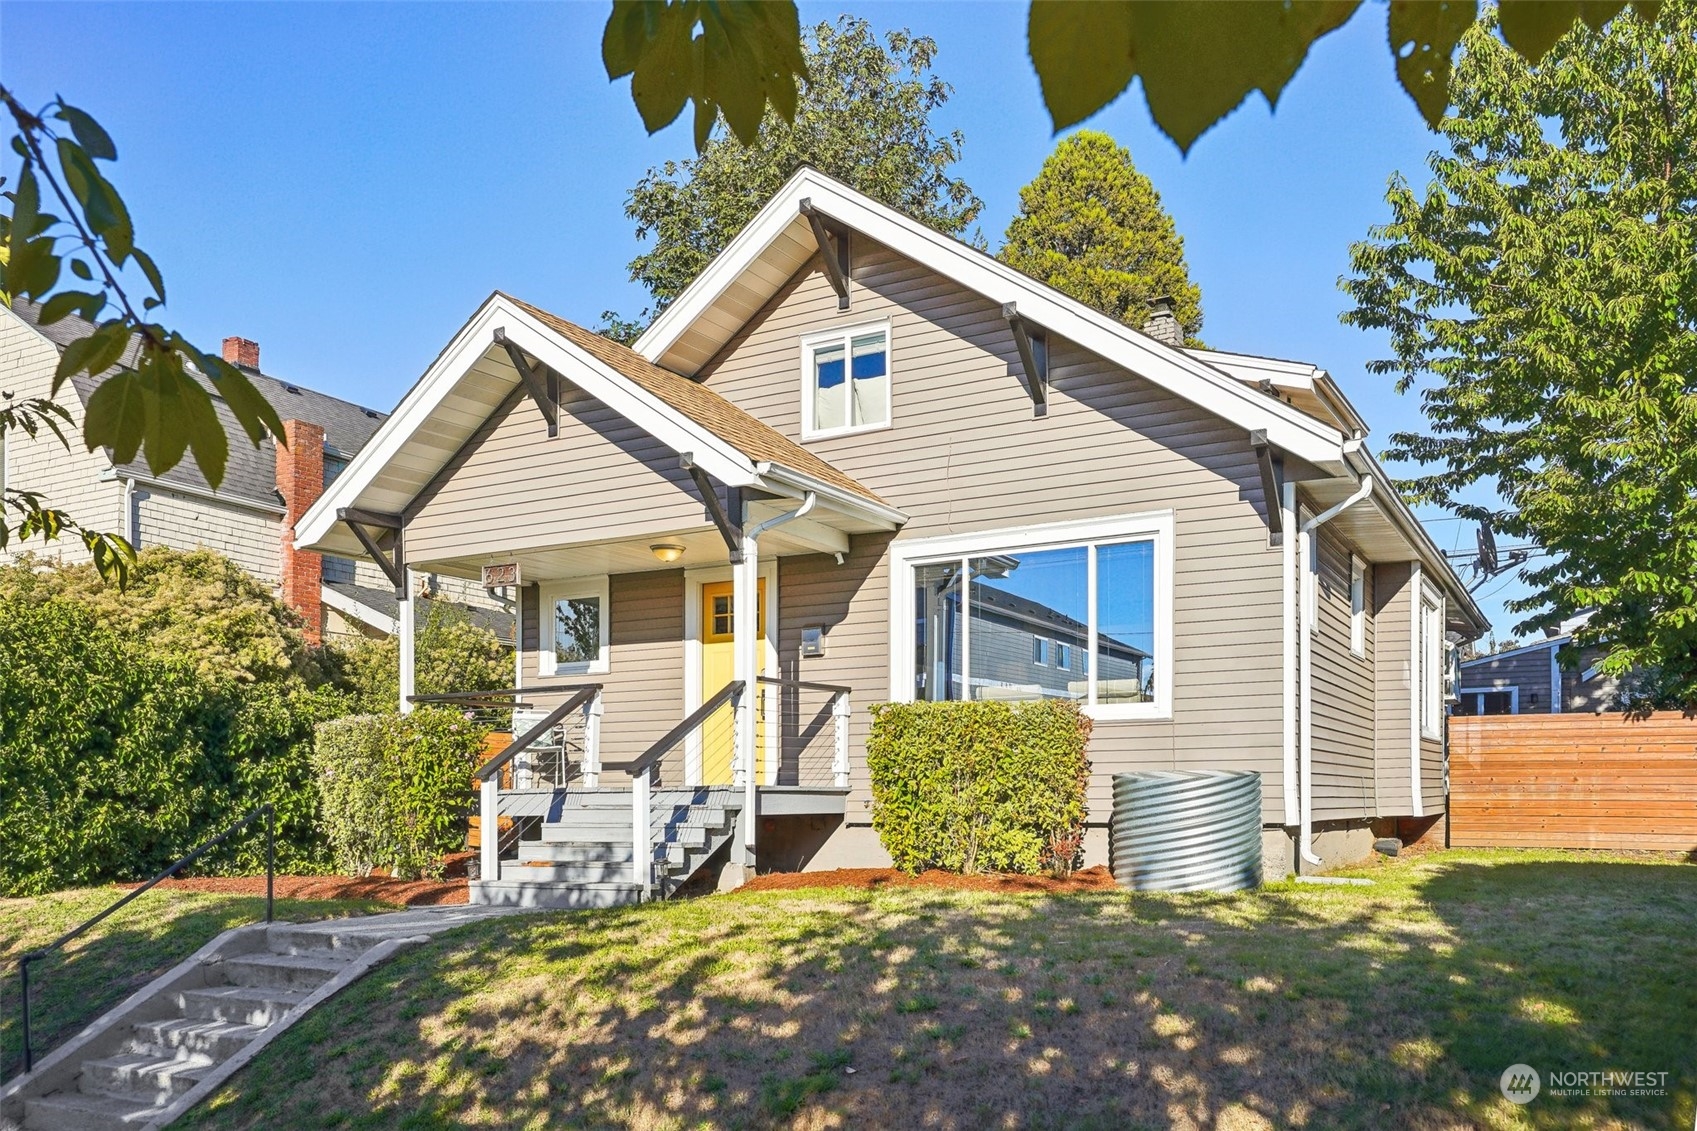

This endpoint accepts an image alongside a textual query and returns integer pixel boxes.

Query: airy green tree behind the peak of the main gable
[604,17,983,338]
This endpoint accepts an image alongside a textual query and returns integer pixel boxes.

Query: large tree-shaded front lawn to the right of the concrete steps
[175,851,1697,1129]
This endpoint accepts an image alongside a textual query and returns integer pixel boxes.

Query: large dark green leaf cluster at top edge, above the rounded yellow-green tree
[1028,0,1361,151]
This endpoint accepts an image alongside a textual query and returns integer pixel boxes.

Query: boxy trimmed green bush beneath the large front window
[865,700,1089,873]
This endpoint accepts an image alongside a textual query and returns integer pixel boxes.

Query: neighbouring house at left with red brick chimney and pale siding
[0,301,512,642]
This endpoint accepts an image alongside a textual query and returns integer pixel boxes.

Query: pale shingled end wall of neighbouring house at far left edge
[0,306,124,562]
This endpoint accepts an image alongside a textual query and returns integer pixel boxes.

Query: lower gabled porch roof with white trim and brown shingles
[295,290,906,557]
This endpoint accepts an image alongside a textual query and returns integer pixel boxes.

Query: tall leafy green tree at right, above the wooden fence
[1344,13,1697,706]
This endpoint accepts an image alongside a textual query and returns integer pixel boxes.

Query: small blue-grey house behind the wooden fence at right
[1453,613,1621,715]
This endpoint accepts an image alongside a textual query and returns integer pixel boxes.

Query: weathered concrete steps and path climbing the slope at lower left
[0,907,522,1131]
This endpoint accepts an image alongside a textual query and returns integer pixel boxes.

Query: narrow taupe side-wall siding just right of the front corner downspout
[1310,526,1376,820]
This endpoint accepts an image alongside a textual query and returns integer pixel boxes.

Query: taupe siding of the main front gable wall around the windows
[704,239,1283,822]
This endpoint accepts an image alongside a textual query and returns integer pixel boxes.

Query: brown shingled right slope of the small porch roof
[502,292,889,506]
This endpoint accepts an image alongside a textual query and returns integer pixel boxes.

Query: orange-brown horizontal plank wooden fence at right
[1449,712,1697,852]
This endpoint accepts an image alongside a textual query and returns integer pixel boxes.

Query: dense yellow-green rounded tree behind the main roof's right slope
[996,131,1201,341]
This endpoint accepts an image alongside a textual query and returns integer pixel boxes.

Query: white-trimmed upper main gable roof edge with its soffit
[635,166,1346,474]
